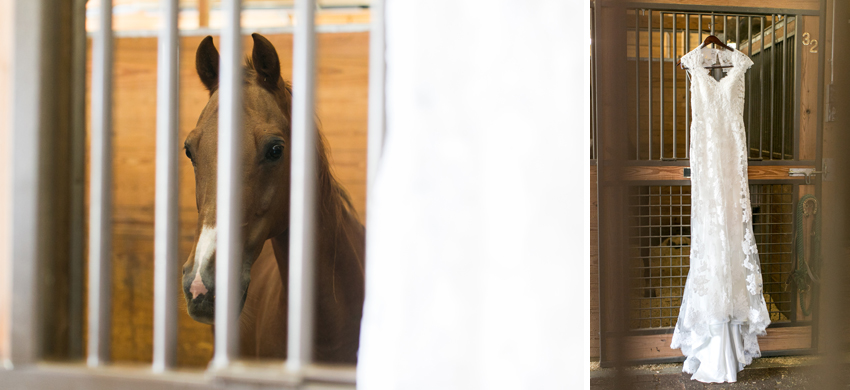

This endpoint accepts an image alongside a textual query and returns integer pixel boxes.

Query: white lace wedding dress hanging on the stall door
[670,45,770,382]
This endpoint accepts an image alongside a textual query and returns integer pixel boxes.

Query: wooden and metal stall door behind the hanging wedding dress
[595,4,824,362]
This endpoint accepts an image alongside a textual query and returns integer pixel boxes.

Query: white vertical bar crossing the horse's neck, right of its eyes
[286,0,316,372]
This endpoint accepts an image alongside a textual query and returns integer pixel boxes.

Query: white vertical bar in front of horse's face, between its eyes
[211,0,243,369]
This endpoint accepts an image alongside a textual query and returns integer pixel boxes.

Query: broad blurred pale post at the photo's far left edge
[0,1,45,368]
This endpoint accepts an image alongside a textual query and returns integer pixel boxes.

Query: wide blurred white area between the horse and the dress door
[357,0,590,390]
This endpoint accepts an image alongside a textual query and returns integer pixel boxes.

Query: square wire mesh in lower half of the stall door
[628,184,796,329]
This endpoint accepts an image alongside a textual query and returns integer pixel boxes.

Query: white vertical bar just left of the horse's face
[153,0,179,372]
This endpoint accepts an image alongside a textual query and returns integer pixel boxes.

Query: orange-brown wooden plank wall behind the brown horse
[87,32,369,366]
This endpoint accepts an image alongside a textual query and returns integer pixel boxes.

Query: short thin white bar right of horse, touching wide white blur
[366,0,387,192]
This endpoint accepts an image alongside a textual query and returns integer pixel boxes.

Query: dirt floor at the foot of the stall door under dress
[590,356,850,390]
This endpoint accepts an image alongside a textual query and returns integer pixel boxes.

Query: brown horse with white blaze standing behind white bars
[183,34,365,363]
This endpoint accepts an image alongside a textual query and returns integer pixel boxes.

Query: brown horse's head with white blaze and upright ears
[182,34,292,324]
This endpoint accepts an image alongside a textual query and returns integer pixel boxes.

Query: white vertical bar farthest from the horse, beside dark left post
[88,0,112,367]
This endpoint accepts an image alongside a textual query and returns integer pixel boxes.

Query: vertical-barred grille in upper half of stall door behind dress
[624,9,798,161]
